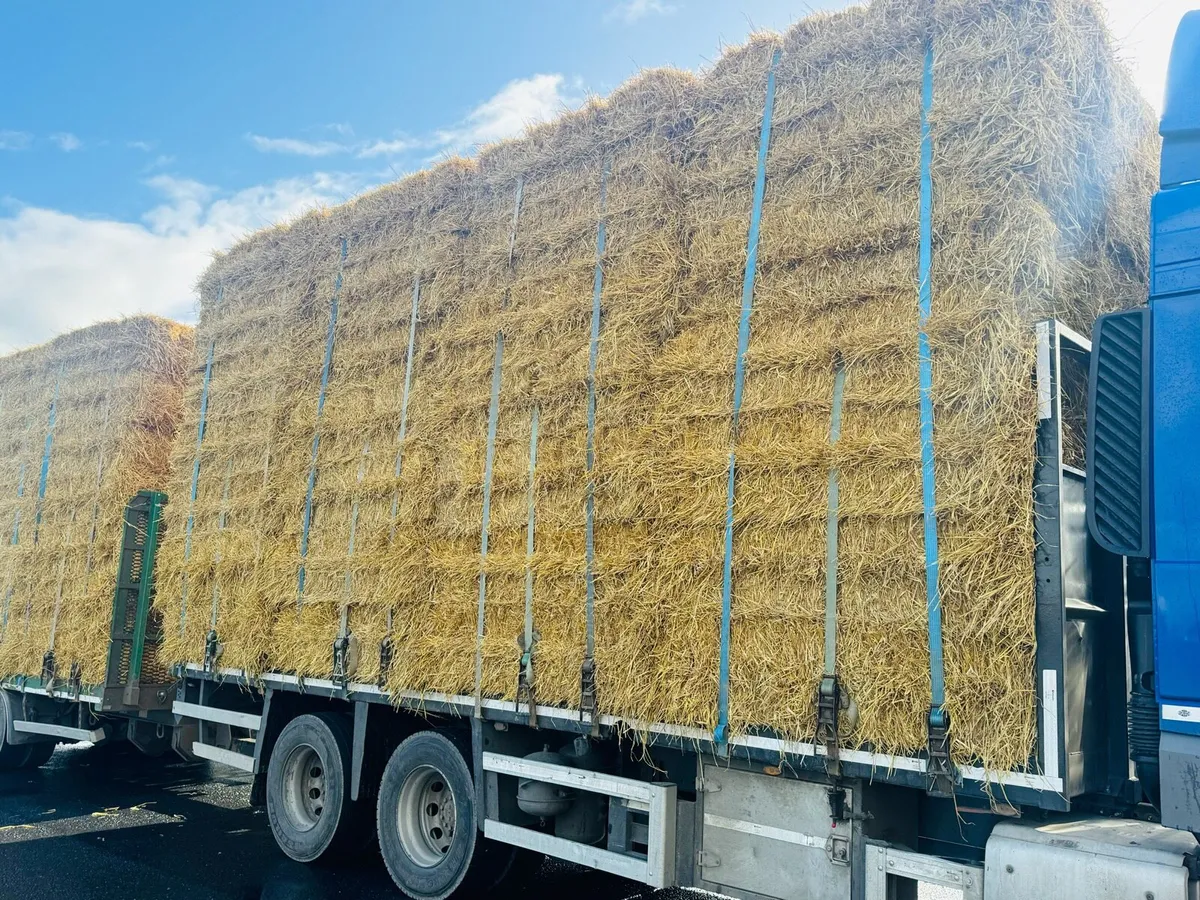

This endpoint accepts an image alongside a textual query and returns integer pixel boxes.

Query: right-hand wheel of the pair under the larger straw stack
[376,731,516,900]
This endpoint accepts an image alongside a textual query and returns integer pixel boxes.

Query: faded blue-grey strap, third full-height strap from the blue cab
[580,156,612,726]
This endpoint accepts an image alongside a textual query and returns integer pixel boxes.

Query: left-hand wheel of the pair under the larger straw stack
[266,713,366,863]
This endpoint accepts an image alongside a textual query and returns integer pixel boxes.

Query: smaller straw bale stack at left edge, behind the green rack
[0,317,192,684]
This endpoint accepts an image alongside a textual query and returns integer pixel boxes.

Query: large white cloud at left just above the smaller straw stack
[0,174,365,352]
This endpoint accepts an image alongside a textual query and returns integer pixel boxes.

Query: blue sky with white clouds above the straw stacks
[0,0,1185,352]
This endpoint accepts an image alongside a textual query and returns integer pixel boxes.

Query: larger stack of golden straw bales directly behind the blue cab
[158,0,1154,767]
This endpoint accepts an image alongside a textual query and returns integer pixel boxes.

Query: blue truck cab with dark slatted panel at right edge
[1088,11,1200,832]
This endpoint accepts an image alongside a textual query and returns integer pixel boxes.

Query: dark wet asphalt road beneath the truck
[0,744,662,900]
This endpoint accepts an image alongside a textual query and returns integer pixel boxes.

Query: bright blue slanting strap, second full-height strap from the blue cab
[713,49,781,755]
